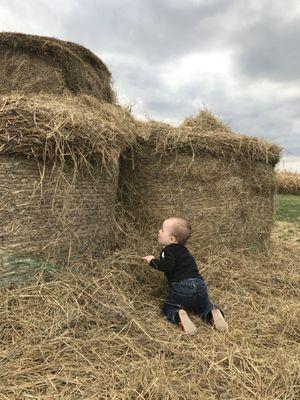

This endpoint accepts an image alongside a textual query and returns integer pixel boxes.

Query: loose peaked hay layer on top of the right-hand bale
[138,110,282,165]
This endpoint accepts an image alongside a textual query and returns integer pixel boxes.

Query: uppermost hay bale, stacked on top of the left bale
[0,32,115,103]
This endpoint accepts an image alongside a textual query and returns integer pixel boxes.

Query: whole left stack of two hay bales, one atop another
[0,33,134,286]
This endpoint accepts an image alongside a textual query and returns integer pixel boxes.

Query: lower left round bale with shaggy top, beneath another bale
[0,95,134,276]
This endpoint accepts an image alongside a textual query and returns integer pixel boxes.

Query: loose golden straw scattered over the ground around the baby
[0,225,300,400]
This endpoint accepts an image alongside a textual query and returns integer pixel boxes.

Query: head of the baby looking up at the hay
[158,217,191,246]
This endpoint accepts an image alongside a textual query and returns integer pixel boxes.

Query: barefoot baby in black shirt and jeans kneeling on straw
[143,217,228,334]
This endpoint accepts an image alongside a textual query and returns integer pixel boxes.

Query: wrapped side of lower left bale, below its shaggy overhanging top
[0,155,118,262]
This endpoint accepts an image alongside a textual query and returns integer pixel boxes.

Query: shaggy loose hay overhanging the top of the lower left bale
[0,93,136,164]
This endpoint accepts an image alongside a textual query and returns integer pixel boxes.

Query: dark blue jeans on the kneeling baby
[162,277,223,324]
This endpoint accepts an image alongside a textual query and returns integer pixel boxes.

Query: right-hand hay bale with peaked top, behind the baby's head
[121,111,280,251]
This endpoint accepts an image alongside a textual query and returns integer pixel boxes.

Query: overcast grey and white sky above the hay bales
[0,0,300,172]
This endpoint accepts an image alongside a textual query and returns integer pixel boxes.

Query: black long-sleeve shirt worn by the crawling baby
[149,243,201,283]
